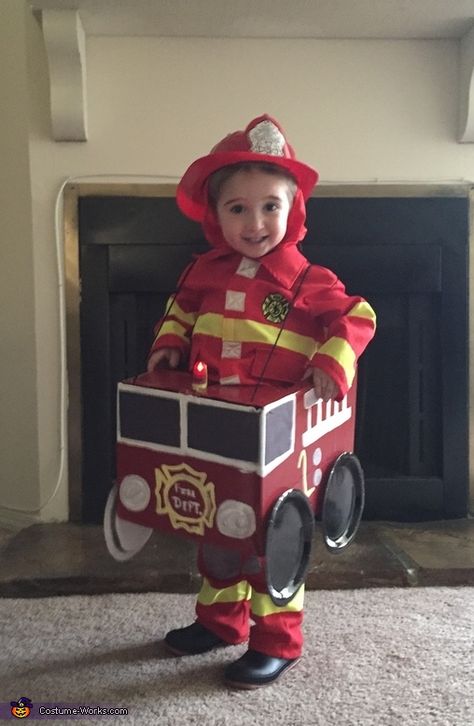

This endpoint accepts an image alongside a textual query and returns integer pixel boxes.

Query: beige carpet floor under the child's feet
[0,587,474,726]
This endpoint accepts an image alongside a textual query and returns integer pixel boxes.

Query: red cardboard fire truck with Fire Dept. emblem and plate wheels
[104,369,364,605]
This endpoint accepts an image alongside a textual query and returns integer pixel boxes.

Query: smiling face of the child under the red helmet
[216,169,293,259]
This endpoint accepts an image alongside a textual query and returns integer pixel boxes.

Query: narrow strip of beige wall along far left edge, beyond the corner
[0,0,39,518]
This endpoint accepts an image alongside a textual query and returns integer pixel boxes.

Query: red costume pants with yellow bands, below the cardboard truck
[196,549,304,658]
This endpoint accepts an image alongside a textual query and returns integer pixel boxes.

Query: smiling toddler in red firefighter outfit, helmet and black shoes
[148,115,375,688]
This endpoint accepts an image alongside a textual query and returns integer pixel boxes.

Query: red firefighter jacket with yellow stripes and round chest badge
[153,243,374,398]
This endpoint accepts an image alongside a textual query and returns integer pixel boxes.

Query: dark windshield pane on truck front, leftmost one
[120,391,180,446]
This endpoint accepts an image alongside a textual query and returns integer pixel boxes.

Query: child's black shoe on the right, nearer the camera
[224,650,299,688]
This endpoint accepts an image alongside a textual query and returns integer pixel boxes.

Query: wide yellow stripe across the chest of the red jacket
[194,313,318,358]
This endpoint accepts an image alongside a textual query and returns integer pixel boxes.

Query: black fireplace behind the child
[70,182,469,523]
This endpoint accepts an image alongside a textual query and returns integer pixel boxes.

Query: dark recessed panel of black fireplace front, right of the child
[356,295,443,478]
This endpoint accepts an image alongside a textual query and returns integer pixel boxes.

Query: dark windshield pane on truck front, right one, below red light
[188,403,259,462]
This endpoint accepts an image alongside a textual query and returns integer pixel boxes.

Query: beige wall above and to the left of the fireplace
[0,0,474,521]
